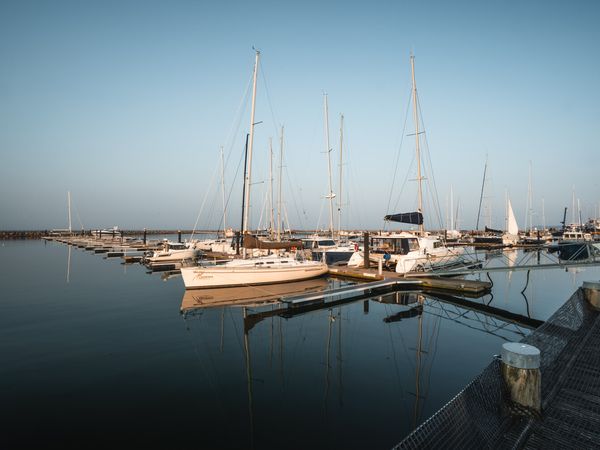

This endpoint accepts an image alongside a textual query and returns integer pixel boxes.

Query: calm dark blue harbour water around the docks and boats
[0,241,600,449]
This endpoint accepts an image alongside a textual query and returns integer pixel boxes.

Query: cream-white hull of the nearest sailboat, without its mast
[181,257,328,289]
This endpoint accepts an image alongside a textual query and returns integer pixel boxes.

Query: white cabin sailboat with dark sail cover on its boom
[348,55,465,274]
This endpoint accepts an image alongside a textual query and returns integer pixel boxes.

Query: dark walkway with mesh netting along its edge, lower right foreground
[396,289,600,449]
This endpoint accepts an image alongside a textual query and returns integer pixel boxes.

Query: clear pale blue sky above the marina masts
[0,0,600,230]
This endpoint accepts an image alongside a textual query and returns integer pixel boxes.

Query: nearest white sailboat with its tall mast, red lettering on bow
[181,50,328,289]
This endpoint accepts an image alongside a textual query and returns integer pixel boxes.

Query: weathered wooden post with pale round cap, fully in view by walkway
[501,342,542,415]
